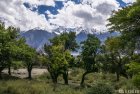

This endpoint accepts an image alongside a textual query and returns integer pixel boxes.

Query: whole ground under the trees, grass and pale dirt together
[0,68,136,94]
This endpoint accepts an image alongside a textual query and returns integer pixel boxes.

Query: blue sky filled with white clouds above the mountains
[0,0,136,32]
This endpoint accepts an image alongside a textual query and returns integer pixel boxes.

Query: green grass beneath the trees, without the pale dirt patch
[0,68,138,94]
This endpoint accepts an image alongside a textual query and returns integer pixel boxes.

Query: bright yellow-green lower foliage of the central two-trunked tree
[45,45,68,73]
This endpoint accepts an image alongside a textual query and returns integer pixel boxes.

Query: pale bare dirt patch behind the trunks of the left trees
[3,68,47,78]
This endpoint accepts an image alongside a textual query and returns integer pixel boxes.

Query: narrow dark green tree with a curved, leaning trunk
[81,34,100,86]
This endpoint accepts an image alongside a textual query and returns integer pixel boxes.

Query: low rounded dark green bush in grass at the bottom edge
[88,83,114,94]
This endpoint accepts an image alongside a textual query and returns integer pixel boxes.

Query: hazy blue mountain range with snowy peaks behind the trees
[21,27,118,51]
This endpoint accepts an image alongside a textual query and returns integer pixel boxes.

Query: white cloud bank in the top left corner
[0,0,51,31]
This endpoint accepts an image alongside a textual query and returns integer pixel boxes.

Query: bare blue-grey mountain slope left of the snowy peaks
[21,30,56,51]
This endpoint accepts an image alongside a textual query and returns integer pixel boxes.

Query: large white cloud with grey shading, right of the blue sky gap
[49,0,119,30]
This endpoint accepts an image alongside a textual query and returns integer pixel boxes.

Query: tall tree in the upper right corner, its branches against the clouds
[108,0,140,54]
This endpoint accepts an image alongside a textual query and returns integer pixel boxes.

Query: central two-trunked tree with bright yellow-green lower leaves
[44,32,78,84]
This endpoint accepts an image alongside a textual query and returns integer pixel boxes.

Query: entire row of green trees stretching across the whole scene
[0,0,140,86]
